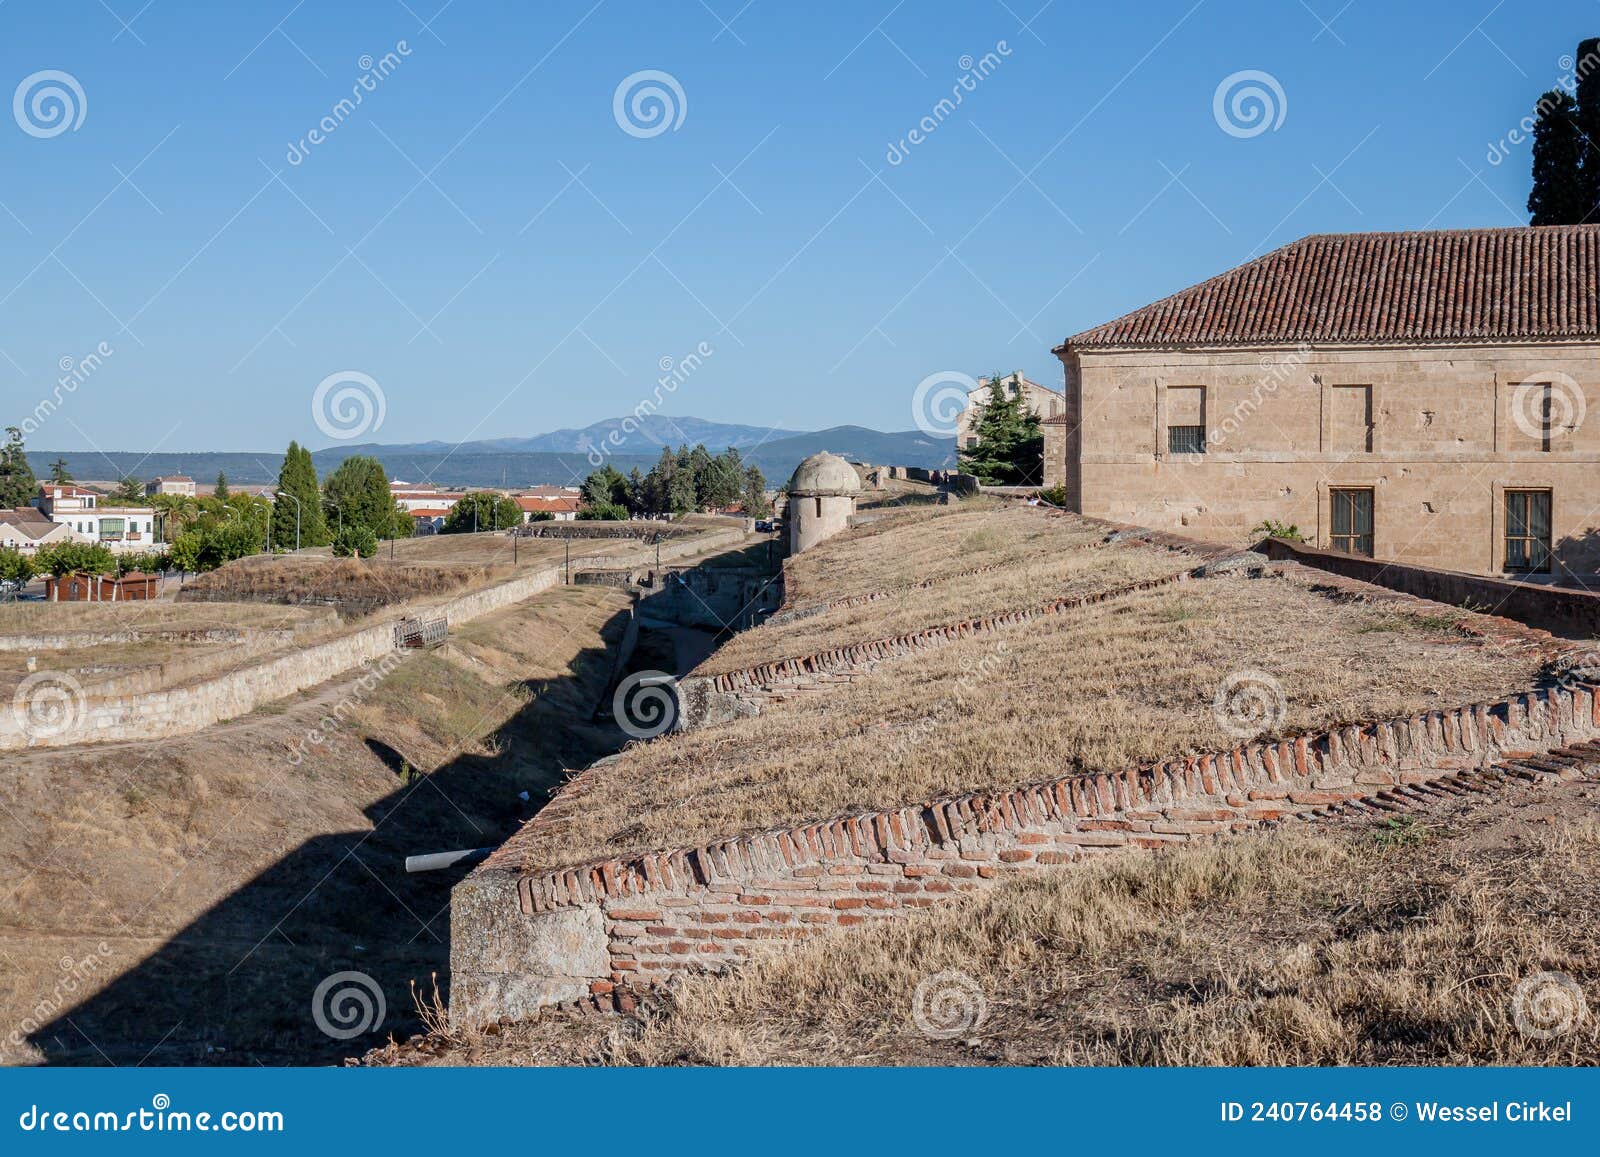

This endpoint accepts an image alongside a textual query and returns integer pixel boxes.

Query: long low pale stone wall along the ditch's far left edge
[0,531,744,751]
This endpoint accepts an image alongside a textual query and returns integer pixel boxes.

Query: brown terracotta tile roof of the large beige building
[1058,226,1600,349]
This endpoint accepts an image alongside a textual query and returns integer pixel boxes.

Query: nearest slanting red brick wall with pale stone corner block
[451,685,1600,1024]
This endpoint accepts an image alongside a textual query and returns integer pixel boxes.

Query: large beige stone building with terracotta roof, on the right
[1045,226,1600,584]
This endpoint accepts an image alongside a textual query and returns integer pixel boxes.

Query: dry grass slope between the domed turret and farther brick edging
[699,507,1198,674]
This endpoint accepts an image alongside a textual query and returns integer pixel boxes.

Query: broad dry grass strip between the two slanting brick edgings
[514,576,1539,867]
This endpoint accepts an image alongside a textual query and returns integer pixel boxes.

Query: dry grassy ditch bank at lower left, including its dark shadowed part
[0,587,627,1064]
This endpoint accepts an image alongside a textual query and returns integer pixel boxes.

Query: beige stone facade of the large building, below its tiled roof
[1046,342,1600,576]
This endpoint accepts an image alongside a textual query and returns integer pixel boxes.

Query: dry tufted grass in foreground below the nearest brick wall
[605,795,1600,1066]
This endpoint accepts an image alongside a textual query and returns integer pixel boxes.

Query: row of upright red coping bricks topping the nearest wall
[518,683,1600,920]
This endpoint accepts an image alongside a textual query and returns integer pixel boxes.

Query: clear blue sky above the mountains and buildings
[0,0,1600,451]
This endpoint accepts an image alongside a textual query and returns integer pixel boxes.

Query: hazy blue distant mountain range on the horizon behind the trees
[27,414,955,486]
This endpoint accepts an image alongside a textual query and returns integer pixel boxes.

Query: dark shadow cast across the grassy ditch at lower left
[27,611,627,1064]
